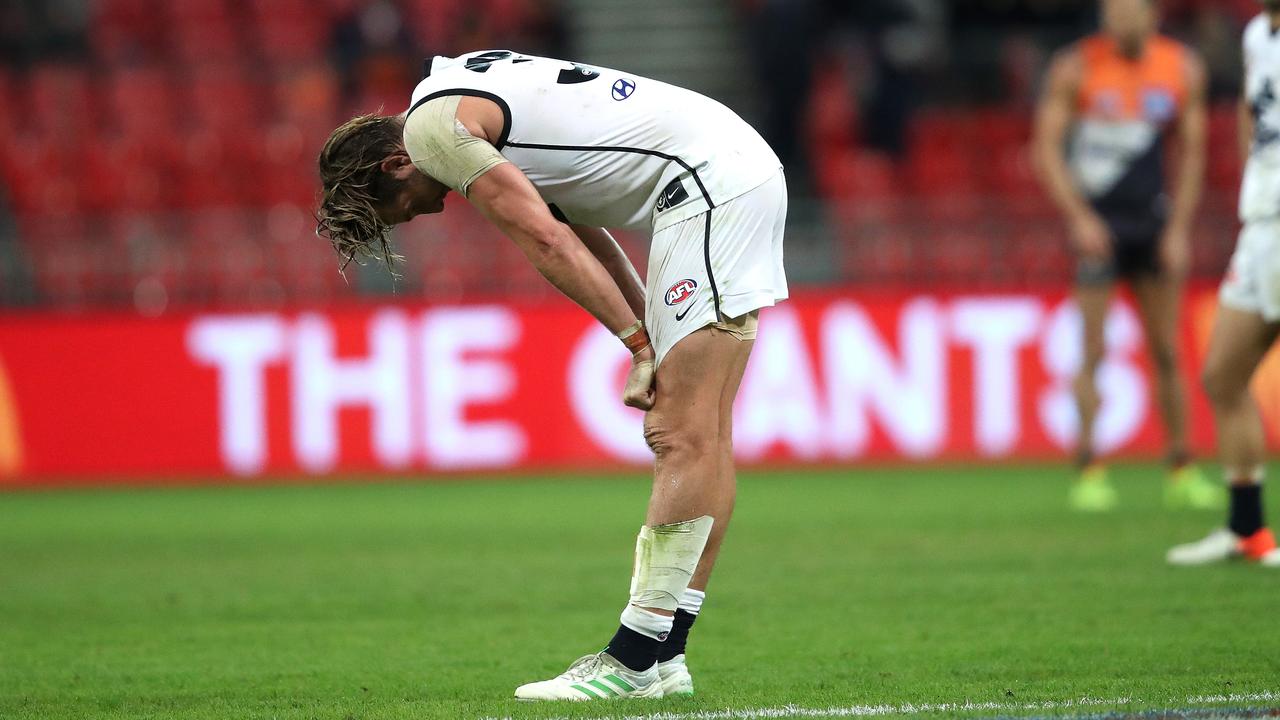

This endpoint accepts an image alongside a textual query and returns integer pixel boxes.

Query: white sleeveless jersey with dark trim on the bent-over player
[408,50,782,231]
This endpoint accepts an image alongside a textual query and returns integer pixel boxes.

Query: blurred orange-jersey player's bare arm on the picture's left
[1032,47,1111,259]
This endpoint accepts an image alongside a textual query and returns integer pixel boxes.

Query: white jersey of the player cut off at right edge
[1240,13,1280,222]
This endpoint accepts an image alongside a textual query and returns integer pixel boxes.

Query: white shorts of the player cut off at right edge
[1219,218,1280,323]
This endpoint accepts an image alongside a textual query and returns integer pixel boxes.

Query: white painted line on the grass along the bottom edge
[485,691,1280,720]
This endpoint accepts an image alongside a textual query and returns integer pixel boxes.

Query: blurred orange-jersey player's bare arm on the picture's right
[1160,53,1208,278]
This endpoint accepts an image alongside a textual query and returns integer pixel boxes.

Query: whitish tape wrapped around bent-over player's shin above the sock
[631,515,716,612]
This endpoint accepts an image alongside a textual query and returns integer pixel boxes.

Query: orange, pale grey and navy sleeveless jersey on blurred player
[1069,35,1189,238]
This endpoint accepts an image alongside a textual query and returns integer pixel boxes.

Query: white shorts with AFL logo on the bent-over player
[645,170,787,366]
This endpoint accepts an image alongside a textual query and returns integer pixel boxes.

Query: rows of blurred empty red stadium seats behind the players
[0,0,1239,306]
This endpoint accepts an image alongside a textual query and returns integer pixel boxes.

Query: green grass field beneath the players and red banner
[0,458,1280,720]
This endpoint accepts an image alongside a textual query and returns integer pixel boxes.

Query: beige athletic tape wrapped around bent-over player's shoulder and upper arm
[404,95,507,195]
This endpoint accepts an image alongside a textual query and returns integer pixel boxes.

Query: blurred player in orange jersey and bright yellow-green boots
[1034,0,1221,511]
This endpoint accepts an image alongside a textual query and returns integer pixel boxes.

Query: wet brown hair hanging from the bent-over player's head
[316,114,404,274]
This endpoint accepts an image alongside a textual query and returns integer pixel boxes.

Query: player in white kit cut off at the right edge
[1169,0,1280,568]
